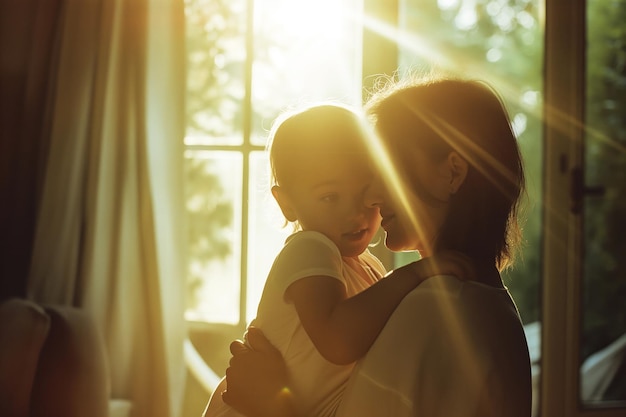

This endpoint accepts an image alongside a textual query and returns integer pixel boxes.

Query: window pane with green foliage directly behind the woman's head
[399,0,543,415]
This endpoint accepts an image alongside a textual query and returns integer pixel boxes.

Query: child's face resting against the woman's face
[280,155,381,256]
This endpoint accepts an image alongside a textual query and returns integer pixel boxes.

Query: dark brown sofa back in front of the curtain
[0,298,130,417]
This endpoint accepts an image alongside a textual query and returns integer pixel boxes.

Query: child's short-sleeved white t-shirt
[207,231,386,417]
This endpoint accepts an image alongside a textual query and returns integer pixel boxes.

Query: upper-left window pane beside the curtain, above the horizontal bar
[185,0,246,145]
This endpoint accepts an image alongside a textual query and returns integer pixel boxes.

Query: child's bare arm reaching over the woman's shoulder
[287,252,472,364]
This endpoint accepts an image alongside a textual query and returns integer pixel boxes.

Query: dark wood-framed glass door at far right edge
[540,0,626,417]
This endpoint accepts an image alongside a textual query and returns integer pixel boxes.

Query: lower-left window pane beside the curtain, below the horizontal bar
[185,150,242,324]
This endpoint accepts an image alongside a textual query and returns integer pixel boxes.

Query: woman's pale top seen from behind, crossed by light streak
[336,276,531,417]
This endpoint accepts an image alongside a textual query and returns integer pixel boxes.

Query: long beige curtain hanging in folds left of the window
[28,0,186,417]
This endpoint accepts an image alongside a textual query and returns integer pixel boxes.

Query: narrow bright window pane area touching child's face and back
[246,152,292,322]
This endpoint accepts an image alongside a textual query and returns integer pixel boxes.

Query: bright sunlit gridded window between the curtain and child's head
[185,0,361,331]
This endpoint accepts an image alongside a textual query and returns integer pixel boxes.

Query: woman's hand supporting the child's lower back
[222,327,296,417]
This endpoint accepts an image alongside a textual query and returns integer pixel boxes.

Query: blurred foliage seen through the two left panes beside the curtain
[185,0,245,310]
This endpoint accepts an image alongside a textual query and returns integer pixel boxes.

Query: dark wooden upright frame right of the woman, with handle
[540,0,626,417]
